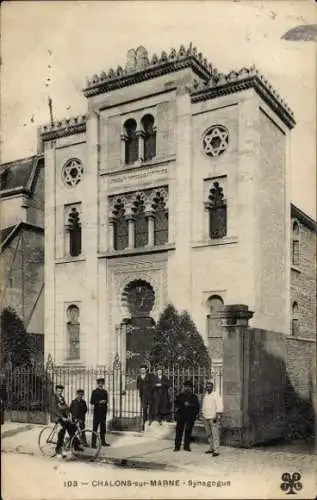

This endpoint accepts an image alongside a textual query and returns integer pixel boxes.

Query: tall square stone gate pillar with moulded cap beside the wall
[220,305,253,448]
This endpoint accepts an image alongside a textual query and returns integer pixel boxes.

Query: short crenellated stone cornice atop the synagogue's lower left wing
[40,115,88,141]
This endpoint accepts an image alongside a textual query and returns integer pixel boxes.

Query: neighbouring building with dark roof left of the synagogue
[0,155,44,350]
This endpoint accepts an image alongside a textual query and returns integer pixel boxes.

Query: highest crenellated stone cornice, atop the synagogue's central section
[83,44,213,97]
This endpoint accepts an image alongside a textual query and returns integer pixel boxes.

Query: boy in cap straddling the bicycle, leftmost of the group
[51,385,83,456]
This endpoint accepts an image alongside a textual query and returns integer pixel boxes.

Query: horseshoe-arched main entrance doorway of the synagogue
[122,279,155,369]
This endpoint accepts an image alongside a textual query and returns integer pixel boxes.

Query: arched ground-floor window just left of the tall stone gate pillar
[207,295,224,361]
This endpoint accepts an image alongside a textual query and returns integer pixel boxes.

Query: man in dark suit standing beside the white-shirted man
[174,380,199,451]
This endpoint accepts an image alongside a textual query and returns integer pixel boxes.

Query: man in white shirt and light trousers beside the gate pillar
[201,381,223,457]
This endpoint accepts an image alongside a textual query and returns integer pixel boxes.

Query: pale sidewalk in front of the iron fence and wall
[1,422,316,477]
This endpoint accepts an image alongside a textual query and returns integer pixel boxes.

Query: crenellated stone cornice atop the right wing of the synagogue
[191,66,296,129]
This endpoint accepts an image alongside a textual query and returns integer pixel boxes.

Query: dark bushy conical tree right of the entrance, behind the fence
[150,304,210,368]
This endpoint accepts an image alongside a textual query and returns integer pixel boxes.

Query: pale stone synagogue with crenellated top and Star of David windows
[36,46,316,365]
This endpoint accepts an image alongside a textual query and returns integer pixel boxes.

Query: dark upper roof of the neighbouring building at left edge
[0,154,44,198]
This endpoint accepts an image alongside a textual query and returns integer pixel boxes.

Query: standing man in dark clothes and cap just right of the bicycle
[90,378,110,448]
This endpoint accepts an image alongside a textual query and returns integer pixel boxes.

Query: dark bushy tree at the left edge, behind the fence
[1,307,31,367]
